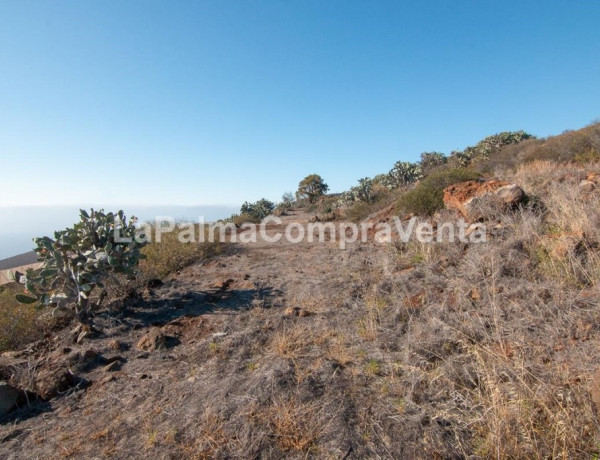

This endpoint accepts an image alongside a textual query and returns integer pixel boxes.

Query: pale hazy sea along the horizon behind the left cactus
[0,205,239,259]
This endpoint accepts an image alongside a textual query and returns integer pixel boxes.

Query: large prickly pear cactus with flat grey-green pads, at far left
[17,209,145,322]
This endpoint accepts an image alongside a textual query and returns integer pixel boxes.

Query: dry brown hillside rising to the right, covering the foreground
[0,124,600,459]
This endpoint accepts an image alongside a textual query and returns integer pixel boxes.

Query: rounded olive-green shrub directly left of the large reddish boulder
[397,168,481,215]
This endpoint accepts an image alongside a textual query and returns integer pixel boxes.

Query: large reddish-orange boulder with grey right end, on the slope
[444,179,525,221]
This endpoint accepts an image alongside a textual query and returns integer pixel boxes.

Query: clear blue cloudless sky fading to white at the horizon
[0,0,600,206]
